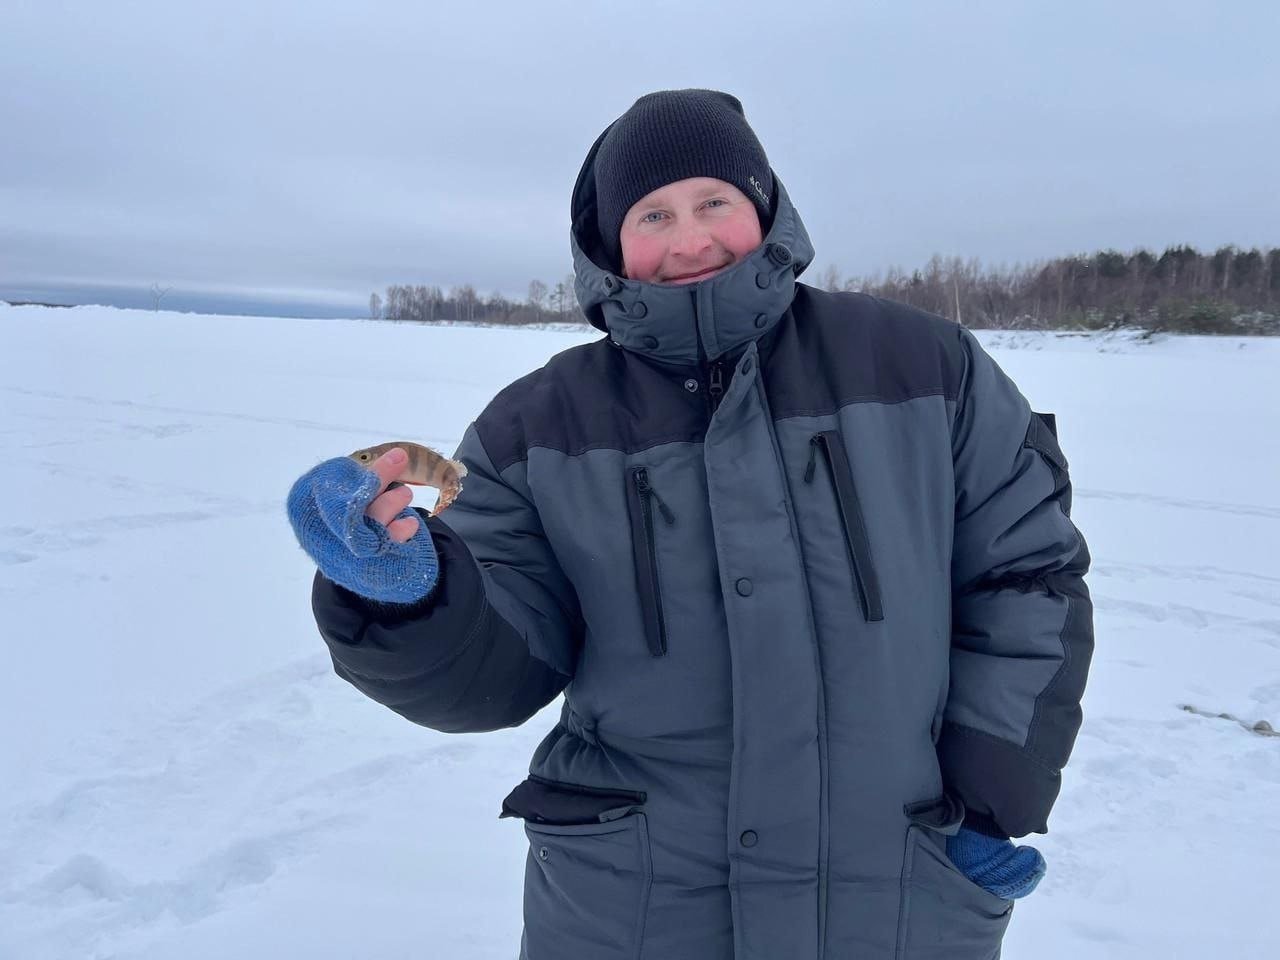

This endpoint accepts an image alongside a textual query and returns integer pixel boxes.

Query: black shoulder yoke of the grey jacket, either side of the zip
[476,293,964,472]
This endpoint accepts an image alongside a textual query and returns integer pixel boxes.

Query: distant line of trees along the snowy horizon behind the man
[369,246,1280,335]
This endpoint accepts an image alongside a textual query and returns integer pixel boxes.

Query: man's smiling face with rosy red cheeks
[620,177,763,284]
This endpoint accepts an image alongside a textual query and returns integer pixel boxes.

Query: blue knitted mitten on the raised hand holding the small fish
[288,457,439,603]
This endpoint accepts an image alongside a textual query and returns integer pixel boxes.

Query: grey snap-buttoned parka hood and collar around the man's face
[570,128,814,362]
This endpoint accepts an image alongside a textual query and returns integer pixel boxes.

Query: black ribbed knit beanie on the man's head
[595,90,773,268]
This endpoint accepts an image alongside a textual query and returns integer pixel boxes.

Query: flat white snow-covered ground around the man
[0,306,1280,960]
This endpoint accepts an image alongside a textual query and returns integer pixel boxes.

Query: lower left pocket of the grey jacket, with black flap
[503,778,653,960]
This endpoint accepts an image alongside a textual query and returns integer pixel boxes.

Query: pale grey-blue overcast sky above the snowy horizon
[0,0,1280,316]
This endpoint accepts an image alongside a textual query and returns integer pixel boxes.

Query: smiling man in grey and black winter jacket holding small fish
[289,91,1093,960]
